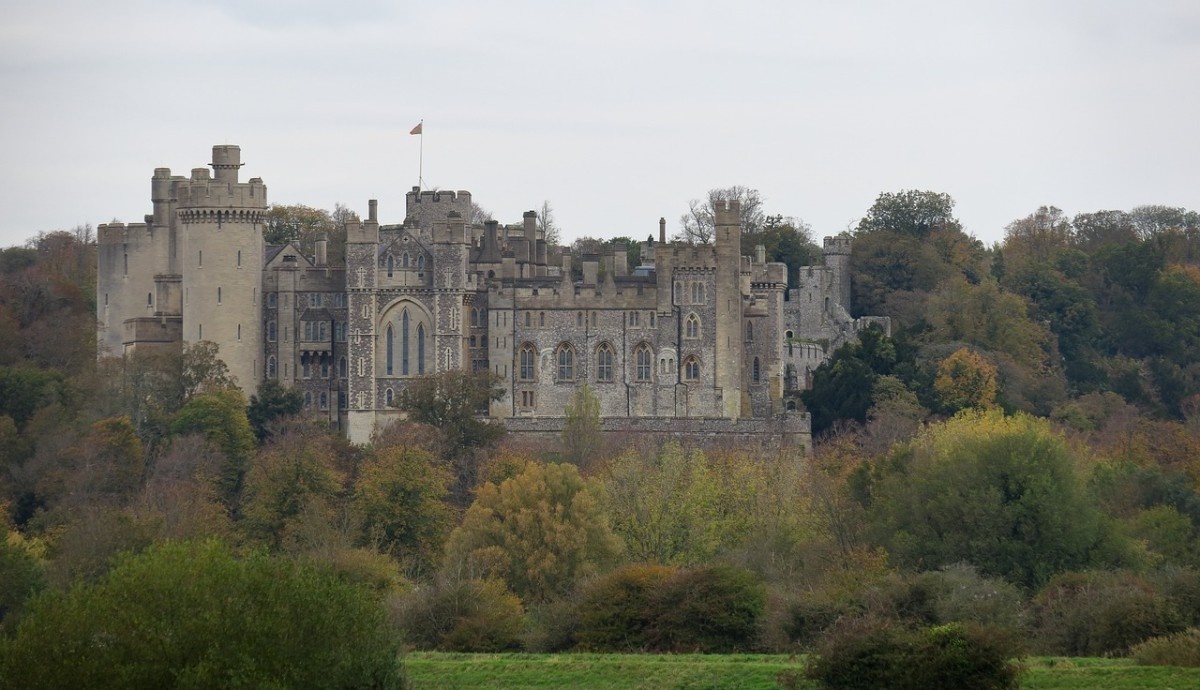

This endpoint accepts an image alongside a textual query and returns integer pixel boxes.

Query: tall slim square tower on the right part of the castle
[715,200,743,419]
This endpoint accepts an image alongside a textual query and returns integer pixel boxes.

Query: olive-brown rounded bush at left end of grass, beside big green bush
[396,580,524,652]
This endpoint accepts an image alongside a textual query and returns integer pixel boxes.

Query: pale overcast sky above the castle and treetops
[0,0,1200,246]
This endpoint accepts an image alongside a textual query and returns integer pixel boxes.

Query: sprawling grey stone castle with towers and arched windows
[97,145,888,443]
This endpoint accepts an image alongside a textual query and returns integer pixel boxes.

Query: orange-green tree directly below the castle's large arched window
[352,445,454,574]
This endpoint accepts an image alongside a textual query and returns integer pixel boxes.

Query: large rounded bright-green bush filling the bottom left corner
[0,541,403,689]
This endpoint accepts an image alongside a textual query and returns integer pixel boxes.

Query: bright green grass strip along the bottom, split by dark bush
[407,652,1200,690]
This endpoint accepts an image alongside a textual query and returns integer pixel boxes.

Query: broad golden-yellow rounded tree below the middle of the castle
[446,464,620,601]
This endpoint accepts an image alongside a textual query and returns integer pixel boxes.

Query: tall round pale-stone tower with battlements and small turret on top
[175,145,266,396]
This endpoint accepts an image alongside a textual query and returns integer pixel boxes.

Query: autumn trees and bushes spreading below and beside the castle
[0,192,1200,686]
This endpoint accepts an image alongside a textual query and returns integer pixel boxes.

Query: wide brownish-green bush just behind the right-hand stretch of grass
[1032,572,1186,656]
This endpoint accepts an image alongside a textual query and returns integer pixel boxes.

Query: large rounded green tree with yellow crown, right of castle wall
[872,410,1126,587]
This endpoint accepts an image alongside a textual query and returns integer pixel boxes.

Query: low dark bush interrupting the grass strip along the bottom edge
[805,618,1020,690]
